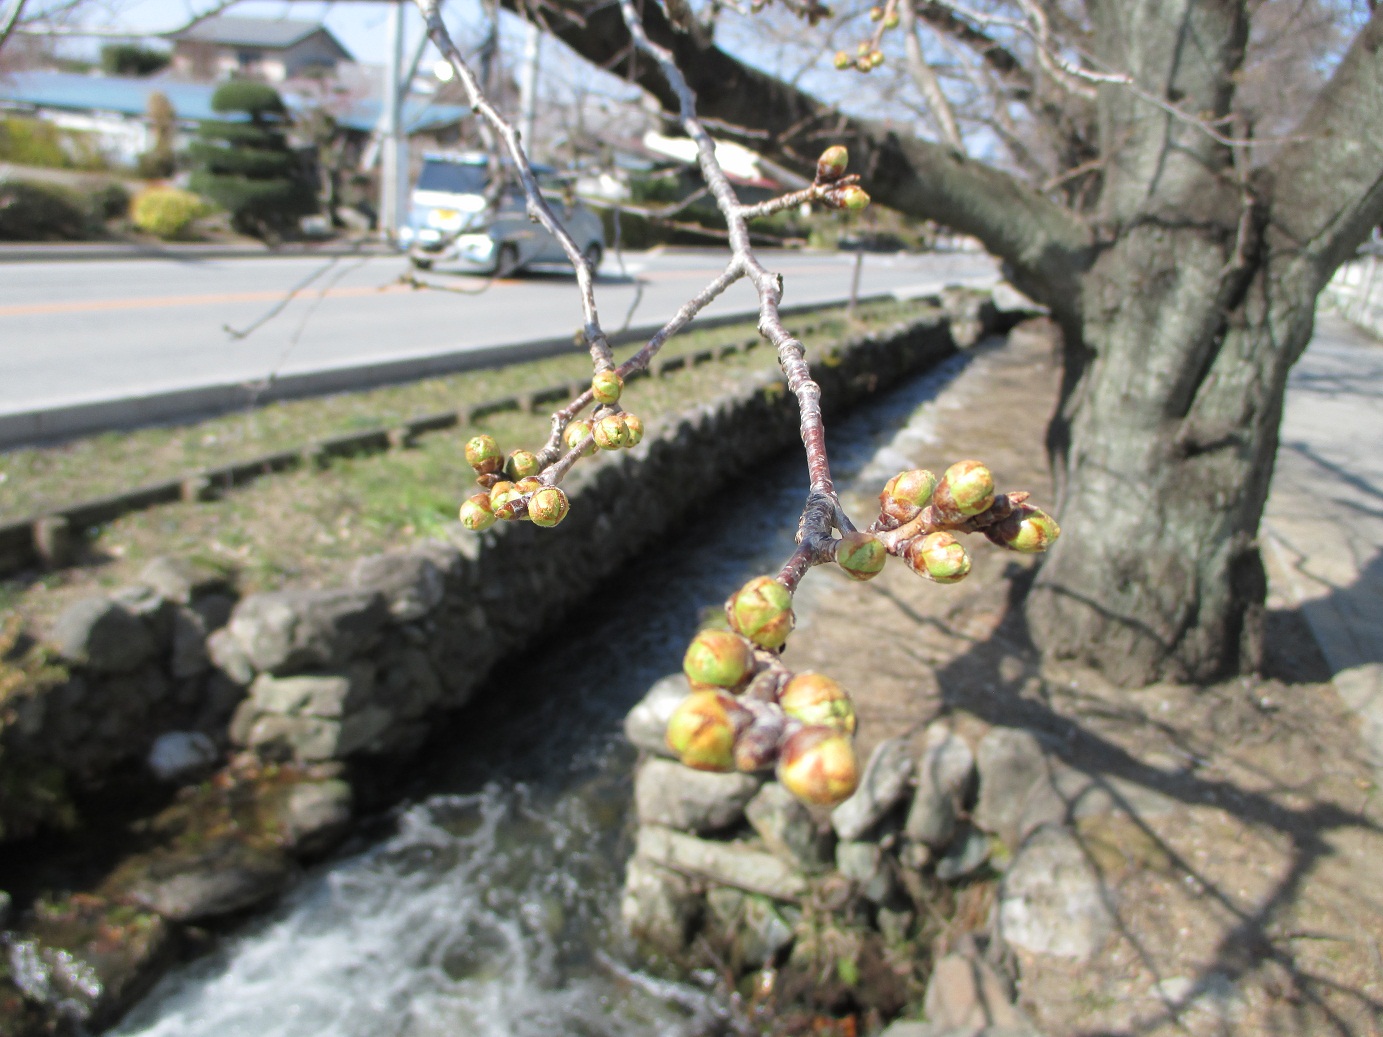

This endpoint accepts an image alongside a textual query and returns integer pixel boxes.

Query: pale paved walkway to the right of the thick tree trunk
[1264,315,1383,776]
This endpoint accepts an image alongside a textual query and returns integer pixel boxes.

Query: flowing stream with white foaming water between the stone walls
[113,349,967,1037]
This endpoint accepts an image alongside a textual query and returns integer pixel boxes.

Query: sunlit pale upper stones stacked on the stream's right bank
[621,675,1145,1037]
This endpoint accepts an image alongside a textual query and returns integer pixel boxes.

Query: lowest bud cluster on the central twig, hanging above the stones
[667,577,859,806]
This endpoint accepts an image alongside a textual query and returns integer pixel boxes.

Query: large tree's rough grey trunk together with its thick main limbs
[520,0,1383,684]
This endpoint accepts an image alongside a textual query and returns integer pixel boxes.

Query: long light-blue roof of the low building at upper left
[0,72,470,133]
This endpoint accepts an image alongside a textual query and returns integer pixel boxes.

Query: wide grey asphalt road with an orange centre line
[0,250,994,415]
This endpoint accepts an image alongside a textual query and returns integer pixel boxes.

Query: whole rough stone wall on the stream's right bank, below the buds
[621,673,1134,1037]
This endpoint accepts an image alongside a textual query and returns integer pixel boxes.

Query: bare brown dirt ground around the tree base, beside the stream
[790,324,1383,1037]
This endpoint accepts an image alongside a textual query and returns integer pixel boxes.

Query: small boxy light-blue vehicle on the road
[398,152,604,277]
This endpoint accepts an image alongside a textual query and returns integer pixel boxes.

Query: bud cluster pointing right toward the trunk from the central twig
[868,460,1061,583]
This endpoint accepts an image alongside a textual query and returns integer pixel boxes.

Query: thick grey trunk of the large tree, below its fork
[1026,225,1318,684]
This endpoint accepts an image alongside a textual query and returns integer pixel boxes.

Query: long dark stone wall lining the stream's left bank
[0,302,1007,835]
